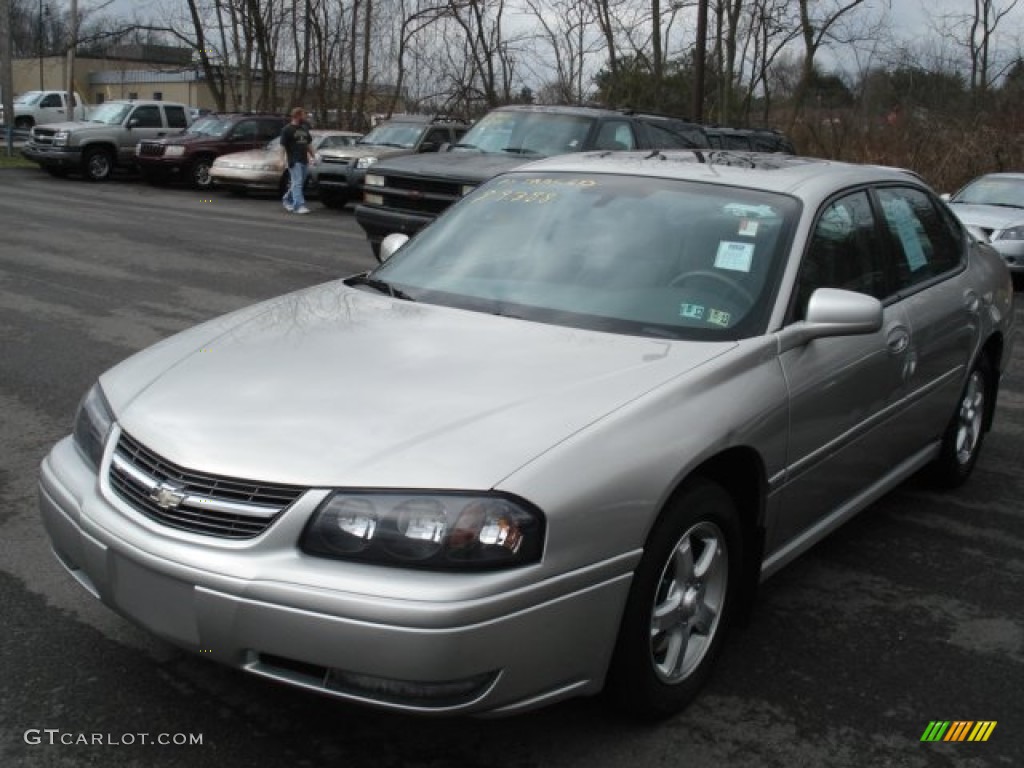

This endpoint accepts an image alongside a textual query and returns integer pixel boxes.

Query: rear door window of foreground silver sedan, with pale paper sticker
[878,187,963,289]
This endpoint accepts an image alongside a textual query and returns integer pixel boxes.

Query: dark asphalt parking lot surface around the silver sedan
[0,169,1024,768]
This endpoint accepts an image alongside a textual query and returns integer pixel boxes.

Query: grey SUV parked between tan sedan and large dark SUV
[314,115,469,208]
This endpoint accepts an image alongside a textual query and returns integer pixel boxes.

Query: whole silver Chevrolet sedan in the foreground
[40,151,1014,718]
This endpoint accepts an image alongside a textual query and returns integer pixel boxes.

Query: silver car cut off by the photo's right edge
[948,173,1024,273]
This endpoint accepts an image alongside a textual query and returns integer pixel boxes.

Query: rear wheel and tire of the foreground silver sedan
[929,355,995,488]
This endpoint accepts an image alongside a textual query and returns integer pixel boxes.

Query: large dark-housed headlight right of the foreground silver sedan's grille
[301,490,544,570]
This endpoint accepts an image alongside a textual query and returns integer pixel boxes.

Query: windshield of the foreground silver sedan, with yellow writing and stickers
[371,172,800,339]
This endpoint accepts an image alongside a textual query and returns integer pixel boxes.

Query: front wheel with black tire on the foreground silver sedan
[605,477,743,720]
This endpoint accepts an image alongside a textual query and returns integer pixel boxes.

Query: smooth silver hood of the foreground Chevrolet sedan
[100,281,735,488]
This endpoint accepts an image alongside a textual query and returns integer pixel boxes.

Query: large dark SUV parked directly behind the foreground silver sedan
[356,106,710,254]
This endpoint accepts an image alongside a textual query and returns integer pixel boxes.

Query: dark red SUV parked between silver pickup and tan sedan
[135,114,288,189]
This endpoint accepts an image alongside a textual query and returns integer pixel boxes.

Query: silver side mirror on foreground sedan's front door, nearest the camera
[778,288,882,352]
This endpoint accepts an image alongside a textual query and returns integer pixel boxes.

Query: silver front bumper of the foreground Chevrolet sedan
[39,438,634,714]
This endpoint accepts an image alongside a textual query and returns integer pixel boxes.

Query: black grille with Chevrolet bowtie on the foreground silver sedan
[110,432,305,539]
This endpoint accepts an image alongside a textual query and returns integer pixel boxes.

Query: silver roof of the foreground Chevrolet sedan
[507,150,926,196]
